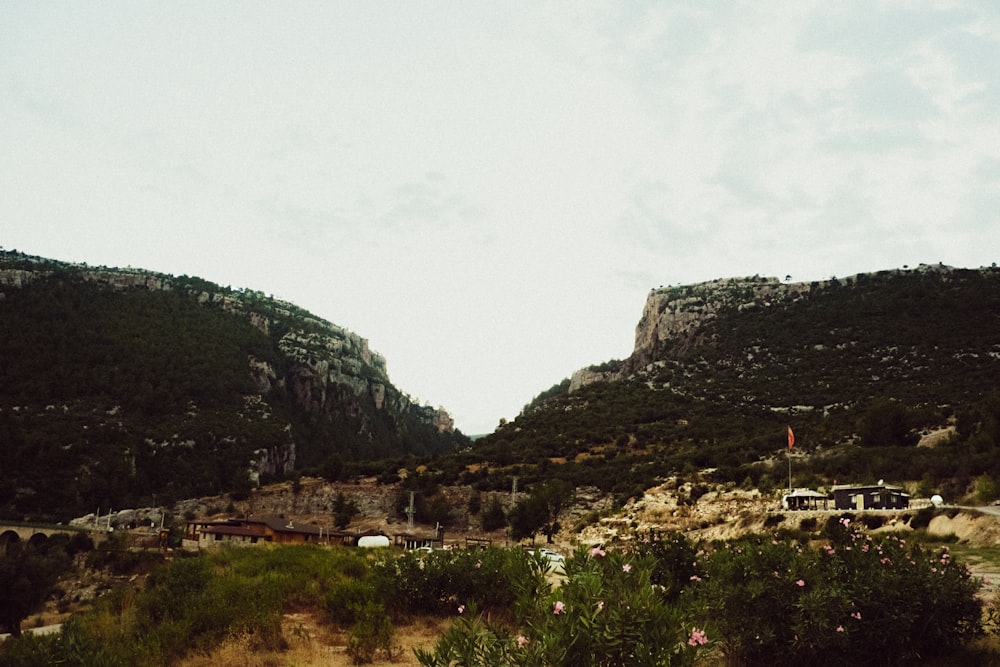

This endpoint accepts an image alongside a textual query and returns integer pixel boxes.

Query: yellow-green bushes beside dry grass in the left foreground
[0,546,378,666]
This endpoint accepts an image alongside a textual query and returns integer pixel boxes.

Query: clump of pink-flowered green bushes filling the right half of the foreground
[419,528,982,667]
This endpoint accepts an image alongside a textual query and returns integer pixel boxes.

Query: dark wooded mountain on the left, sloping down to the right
[0,251,469,518]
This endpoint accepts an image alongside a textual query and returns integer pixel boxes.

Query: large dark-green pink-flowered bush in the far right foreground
[694,517,981,665]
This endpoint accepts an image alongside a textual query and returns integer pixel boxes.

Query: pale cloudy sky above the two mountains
[0,0,1000,434]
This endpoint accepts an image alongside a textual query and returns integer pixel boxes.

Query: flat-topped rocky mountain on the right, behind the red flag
[464,265,1000,500]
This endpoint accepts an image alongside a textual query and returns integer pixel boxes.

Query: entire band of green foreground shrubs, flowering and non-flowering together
[0,515,984,667]
